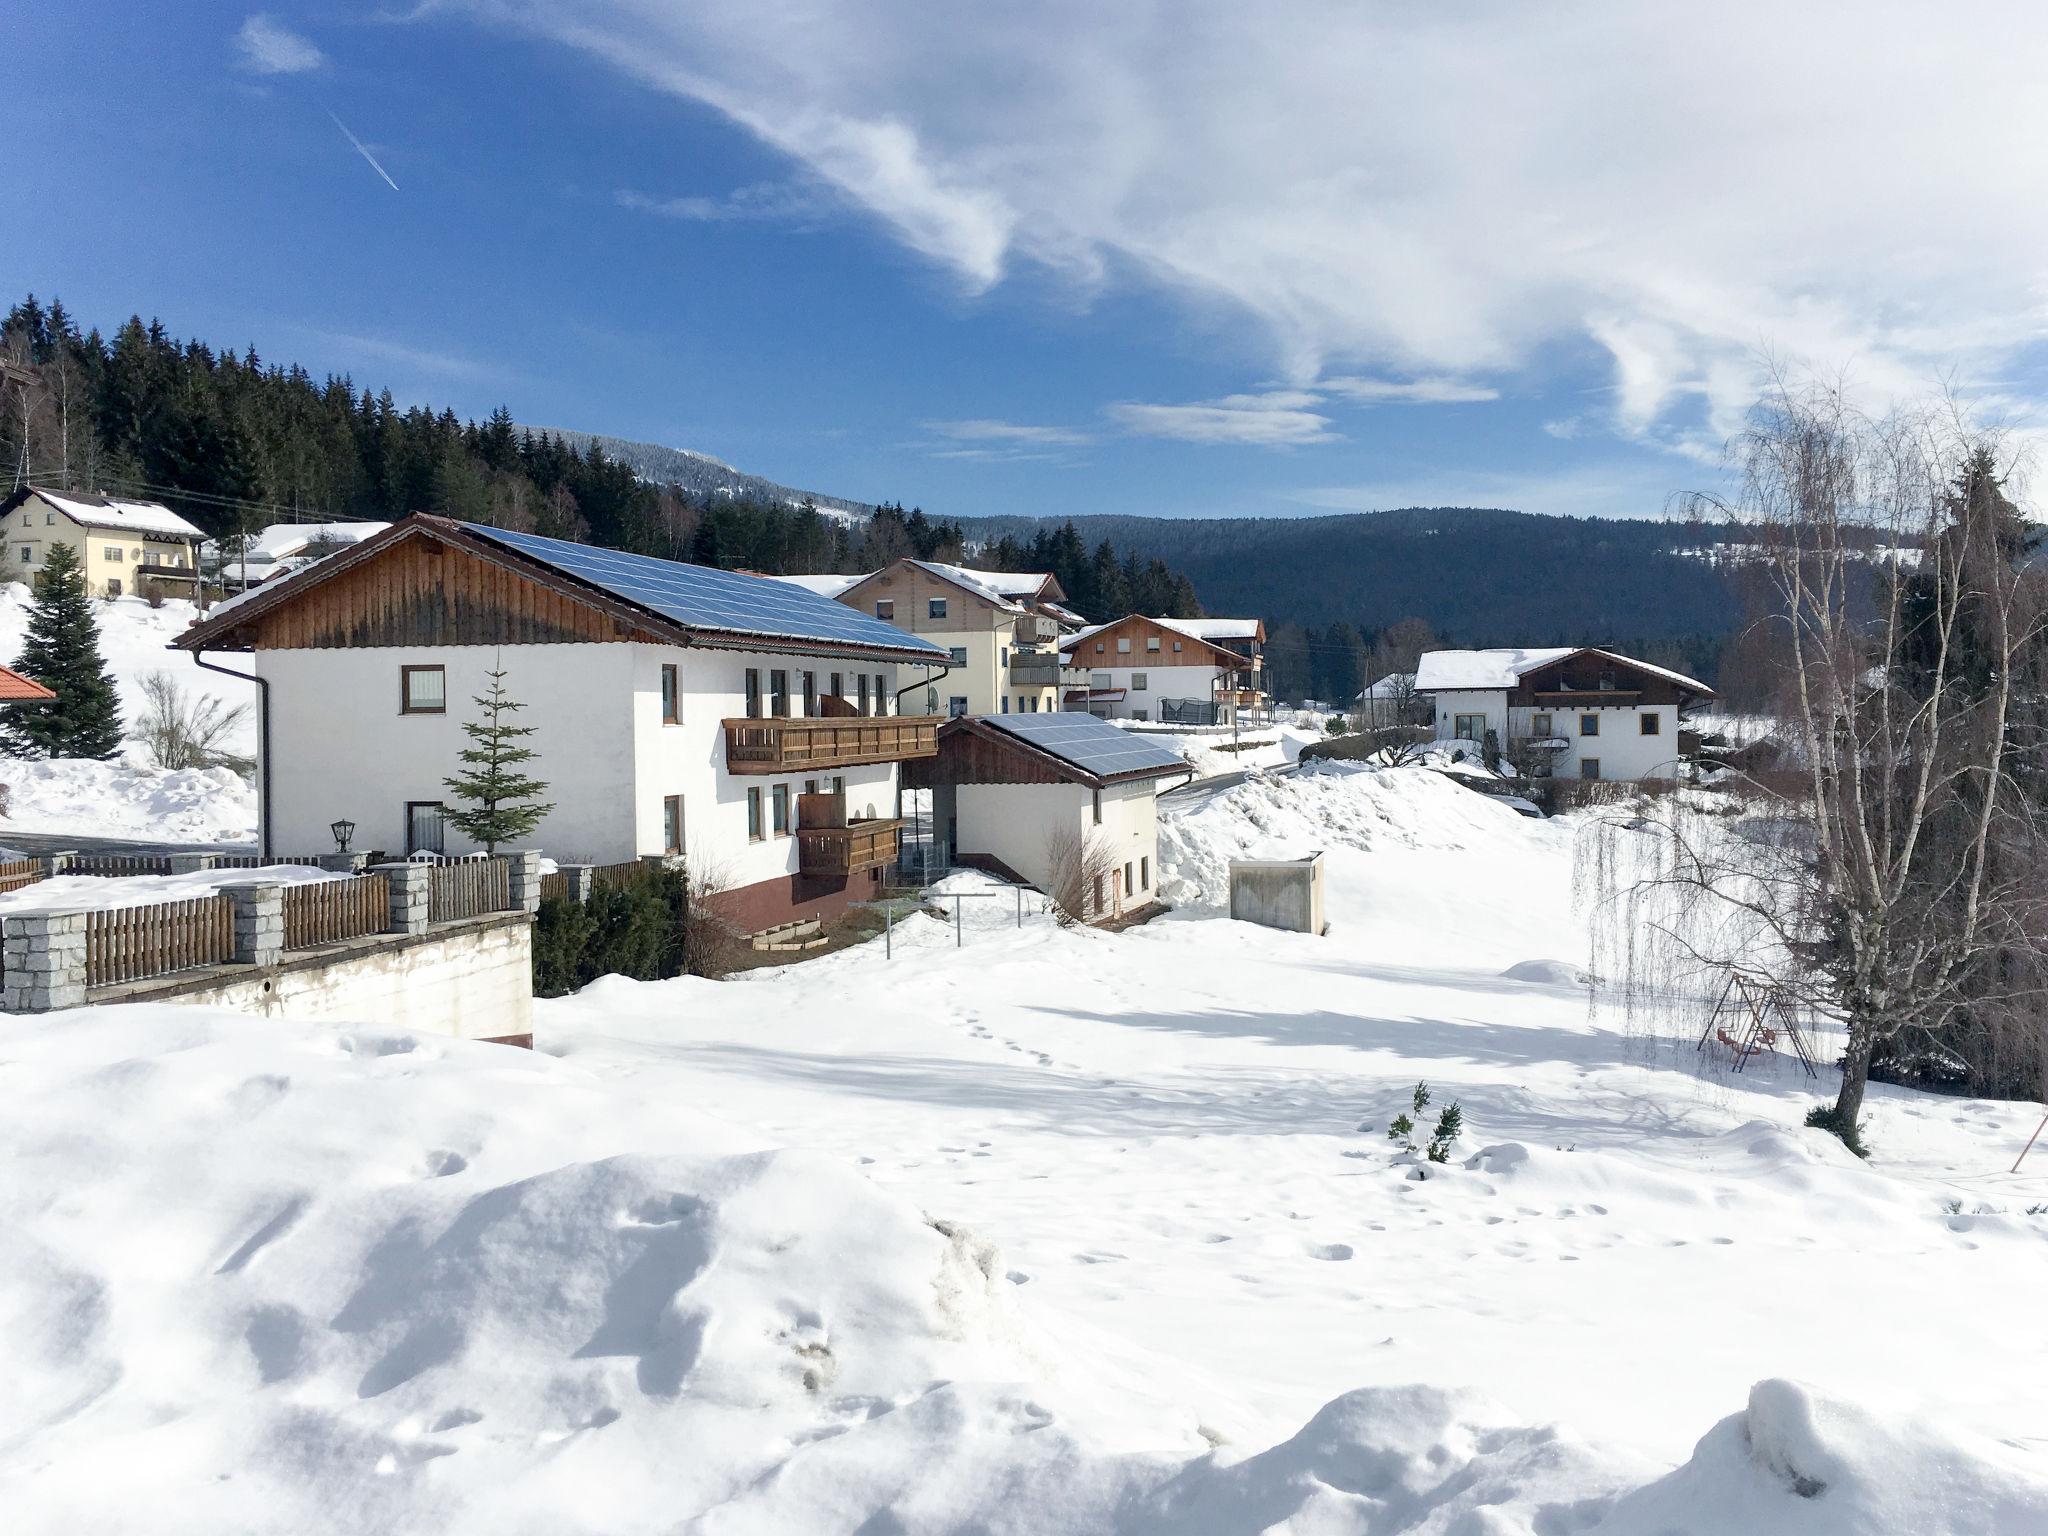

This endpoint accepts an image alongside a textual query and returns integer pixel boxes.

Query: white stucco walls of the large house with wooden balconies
[256,643,899,887]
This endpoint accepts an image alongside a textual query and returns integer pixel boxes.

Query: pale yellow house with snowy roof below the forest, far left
[0,485,207,598]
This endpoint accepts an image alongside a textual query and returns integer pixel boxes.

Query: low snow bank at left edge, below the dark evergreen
[0,758,256,844]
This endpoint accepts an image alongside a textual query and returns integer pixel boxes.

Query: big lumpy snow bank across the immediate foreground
[0,1003,2048,1536]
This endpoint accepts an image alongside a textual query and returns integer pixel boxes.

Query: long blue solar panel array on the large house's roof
[463,522,946,662]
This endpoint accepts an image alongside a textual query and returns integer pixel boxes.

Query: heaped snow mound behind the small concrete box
[1159,762,1571,909]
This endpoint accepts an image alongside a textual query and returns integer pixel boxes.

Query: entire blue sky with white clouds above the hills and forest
[12,0,2048,516]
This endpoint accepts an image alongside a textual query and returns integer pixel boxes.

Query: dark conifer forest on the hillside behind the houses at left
[0,295,1196,618]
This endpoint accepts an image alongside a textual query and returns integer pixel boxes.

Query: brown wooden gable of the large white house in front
[223,537,674,651]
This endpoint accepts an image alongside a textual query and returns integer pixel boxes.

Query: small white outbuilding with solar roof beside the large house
[903,711,1194,922]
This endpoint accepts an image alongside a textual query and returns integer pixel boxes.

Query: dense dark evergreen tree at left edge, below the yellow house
[0,545,121,760]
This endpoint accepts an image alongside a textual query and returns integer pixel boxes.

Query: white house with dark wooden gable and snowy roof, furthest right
[1415,647,1714,778]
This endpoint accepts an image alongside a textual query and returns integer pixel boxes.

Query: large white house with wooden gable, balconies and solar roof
[178,514,946,932]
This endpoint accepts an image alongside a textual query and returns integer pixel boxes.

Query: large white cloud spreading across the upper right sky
[442,0,2048,449]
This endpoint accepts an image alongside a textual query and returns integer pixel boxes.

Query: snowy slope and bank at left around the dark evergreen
[0,582,256,844]
